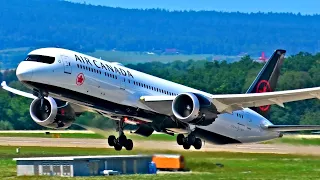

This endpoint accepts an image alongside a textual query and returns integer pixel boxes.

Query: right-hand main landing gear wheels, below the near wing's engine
[177,133,202,149]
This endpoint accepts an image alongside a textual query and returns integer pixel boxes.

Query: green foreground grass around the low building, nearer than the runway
[0,146,320,180]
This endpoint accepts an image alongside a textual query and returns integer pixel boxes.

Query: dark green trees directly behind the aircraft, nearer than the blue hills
[0,52,320,130]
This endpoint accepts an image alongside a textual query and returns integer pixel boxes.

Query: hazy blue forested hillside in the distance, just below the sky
[0,0,320,56]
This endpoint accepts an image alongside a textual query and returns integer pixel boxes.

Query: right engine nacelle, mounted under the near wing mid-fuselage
[172,93,218,126]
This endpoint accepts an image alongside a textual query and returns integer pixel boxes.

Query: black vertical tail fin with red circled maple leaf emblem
[247,49,286,118]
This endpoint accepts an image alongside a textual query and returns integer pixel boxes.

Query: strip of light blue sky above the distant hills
[68,0,320,14]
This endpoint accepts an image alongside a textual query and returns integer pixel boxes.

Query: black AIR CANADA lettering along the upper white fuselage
[75,55,134,78]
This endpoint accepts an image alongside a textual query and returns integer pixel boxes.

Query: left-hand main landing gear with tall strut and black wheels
[108,118,133,151]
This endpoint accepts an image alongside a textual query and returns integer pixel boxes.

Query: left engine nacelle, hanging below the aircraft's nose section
[30,97,76,129]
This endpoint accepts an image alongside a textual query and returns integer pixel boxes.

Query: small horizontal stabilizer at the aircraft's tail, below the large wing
[265,125,320,132]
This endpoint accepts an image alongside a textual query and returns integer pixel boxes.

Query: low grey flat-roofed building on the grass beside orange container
[13,155,156,177]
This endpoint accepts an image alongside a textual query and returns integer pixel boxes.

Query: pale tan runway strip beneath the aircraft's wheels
[0,137,320,156]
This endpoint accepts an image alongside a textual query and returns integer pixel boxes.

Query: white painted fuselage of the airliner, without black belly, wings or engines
[17,48,279,143]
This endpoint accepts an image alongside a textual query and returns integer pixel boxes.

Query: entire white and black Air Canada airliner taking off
[1,48,320,151]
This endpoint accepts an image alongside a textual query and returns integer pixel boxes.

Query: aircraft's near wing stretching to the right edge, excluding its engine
[140,87,320,115]
